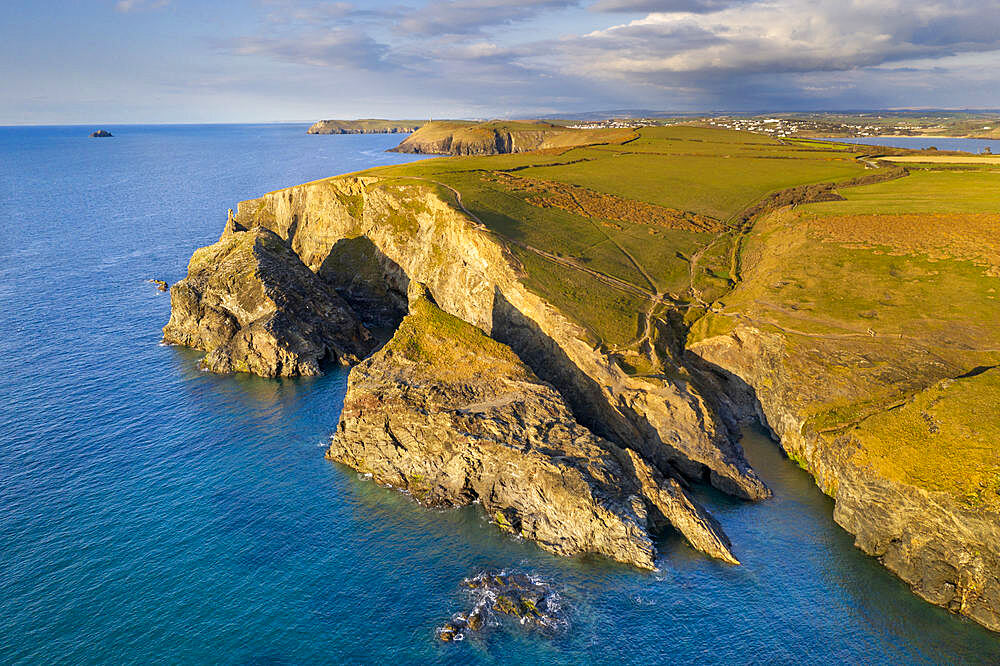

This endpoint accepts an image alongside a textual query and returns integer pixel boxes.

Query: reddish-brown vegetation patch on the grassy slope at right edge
[808,213,1000,277]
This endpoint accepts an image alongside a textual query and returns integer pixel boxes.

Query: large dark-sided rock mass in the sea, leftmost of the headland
[163,224,374,377]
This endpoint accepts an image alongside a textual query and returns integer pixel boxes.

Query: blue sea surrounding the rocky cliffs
[0,125,1000,664]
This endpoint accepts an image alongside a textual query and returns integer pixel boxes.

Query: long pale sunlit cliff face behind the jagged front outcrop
[232,178,769,499]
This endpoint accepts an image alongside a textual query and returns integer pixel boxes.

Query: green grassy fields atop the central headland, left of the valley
[350,126,866,345]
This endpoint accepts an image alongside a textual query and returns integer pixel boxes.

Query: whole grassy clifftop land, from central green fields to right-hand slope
[348,126,1000,505]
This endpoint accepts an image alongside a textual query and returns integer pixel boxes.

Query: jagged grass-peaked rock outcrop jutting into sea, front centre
[327,283,737,569]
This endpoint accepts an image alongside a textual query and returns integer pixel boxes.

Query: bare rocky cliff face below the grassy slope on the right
[687,323,1000,631]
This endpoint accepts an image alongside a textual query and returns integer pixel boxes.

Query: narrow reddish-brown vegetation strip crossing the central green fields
[483,171,724,232]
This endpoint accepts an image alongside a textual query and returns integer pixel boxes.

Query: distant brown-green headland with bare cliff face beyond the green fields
[392,121,634,155]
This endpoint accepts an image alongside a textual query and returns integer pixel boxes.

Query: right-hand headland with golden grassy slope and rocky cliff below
[687,196,1000,630]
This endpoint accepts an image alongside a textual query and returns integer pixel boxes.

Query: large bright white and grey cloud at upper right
[556,0,1000,79]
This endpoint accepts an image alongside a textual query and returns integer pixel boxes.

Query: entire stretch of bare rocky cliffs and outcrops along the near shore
[164,169,1000,629]
